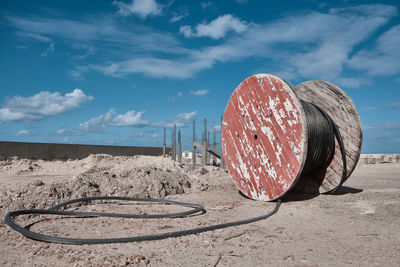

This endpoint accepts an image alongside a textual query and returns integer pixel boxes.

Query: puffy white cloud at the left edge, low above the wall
[0,89,93,122]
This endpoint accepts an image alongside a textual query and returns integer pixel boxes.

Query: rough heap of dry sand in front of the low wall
[0,154,193,222]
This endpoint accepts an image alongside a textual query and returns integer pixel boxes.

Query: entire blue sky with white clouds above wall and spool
[0,0,400,153]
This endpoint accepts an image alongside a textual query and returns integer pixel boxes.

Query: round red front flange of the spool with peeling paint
[222,74,307,201]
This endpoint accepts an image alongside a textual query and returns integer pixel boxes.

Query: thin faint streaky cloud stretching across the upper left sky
[5,15,181,58]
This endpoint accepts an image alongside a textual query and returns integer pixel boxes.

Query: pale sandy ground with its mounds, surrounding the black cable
[0,155,400,266]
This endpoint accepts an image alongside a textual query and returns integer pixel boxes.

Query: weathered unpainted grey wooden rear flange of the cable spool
[293,80,362,193]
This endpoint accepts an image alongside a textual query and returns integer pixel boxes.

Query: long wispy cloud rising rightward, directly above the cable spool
[96,5,400,84]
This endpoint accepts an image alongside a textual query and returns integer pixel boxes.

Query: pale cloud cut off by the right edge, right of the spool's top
[348,25,400,76]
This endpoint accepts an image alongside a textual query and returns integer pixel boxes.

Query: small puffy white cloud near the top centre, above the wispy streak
[179,14,248,39]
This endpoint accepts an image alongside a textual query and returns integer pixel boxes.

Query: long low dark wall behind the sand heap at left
[0,141,171,160]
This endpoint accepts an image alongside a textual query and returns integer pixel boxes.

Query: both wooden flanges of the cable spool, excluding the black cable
[222,74,362,201]
